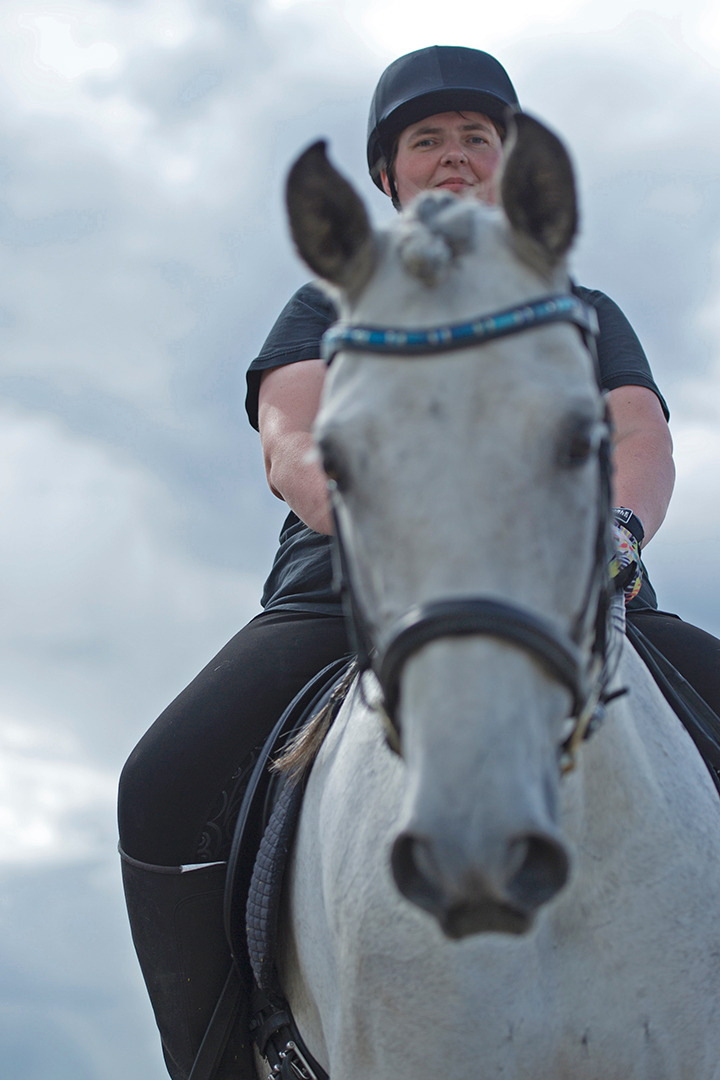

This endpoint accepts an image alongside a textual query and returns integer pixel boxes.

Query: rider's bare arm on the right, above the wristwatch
[608,386,675,545]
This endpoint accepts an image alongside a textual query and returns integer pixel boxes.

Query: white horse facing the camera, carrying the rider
[273,118,720,1080]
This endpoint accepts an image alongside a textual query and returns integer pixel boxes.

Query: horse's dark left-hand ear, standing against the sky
[285,140,376,294]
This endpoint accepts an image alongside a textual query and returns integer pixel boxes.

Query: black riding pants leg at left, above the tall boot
[118,611,350,866]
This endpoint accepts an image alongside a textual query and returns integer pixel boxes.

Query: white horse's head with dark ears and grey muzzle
[287,116,607,937]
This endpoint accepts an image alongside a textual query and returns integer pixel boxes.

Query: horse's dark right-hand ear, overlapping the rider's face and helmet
[500,112,578,265]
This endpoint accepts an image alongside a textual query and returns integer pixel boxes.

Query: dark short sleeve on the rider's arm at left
[245,283,338,431]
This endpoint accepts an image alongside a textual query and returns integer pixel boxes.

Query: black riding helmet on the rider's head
[367,45,518,203]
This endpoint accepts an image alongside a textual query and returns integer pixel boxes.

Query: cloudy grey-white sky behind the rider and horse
[0,0,720,1080]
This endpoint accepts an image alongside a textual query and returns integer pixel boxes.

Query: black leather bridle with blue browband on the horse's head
[323,294,614,771]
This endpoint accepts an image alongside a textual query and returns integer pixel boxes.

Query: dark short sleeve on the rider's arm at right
[572,285,670,420]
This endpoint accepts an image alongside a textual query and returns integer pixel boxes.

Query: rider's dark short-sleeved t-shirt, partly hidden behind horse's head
[245,283,669,615]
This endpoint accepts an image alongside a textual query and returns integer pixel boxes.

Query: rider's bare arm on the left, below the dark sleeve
[258,360,332,534]
